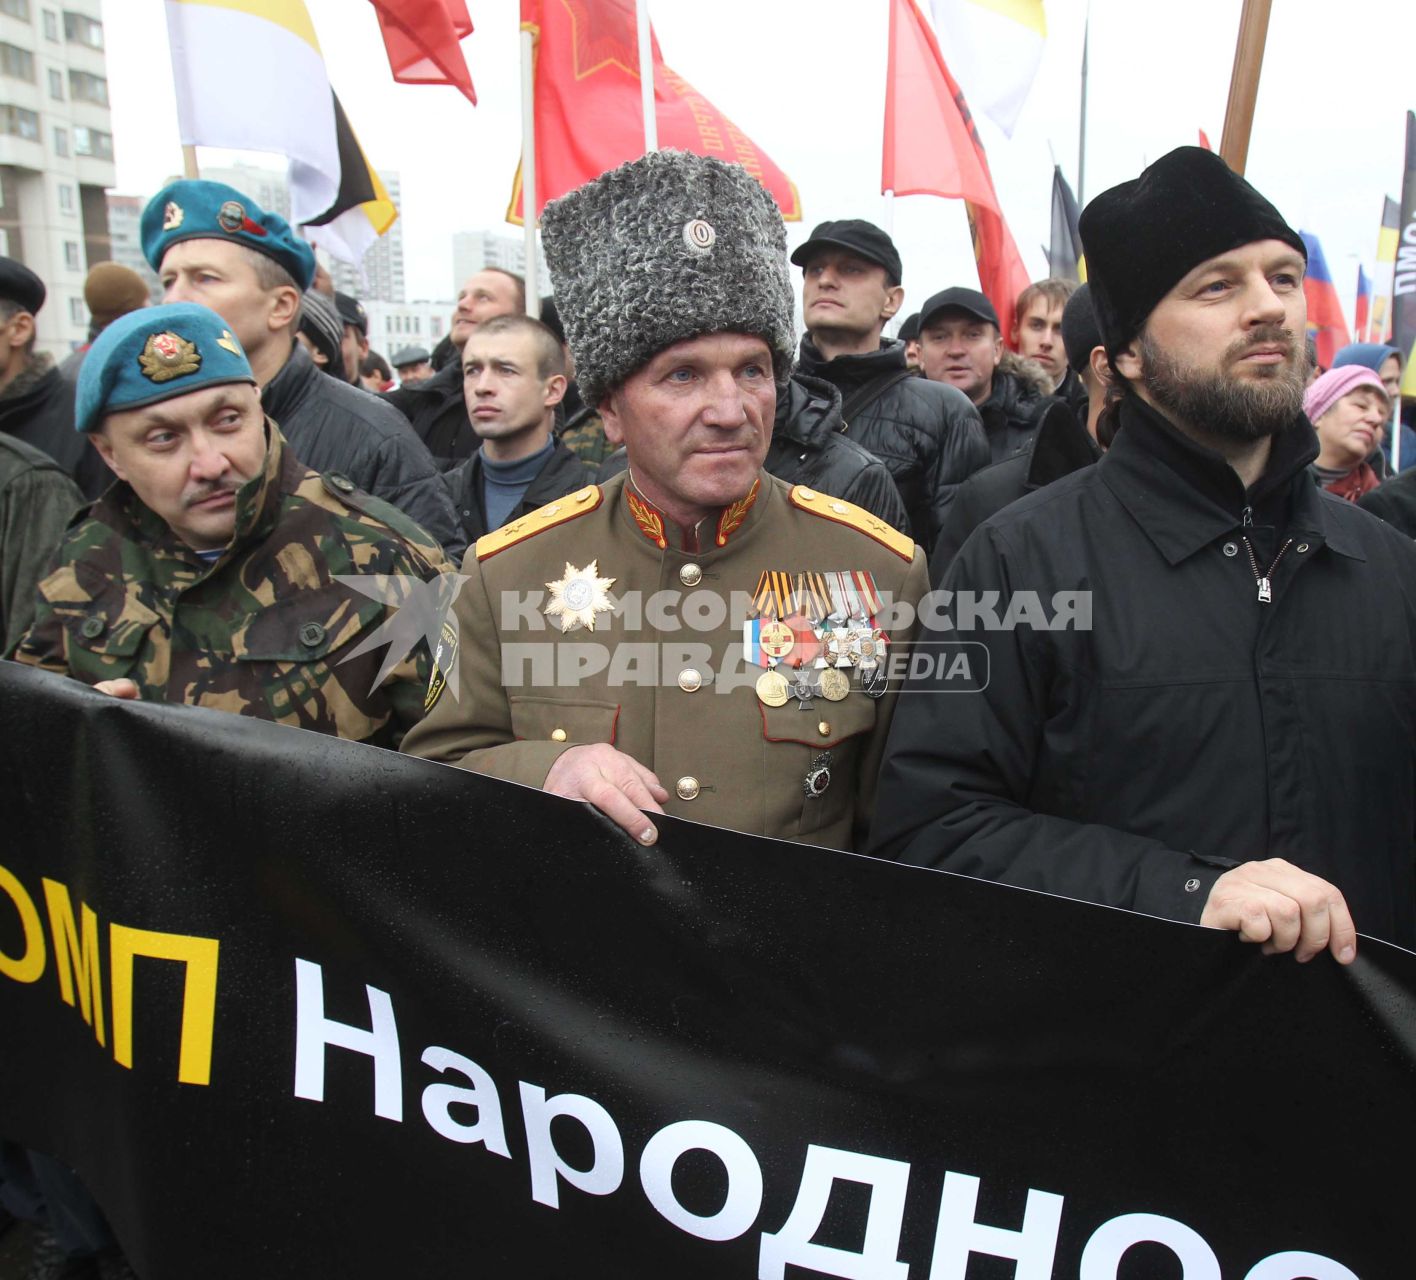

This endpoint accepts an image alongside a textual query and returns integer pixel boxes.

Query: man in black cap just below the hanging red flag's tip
[919,286,1052,462]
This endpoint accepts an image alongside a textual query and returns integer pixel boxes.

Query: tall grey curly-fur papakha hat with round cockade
[541,152,796,405]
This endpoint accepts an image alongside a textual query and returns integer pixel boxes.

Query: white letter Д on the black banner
[758,1143,909,1280]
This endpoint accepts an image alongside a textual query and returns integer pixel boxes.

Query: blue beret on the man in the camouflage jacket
[74,302,256,432]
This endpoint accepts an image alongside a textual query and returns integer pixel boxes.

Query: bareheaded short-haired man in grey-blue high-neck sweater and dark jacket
[447,316,595,547]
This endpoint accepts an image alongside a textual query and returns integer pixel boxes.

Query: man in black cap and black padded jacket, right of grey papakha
[792,219,988,547]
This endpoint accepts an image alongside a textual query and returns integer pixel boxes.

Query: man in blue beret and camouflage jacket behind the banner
[14,303,447,745]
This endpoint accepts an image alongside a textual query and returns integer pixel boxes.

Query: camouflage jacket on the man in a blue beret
[14,419,447,745]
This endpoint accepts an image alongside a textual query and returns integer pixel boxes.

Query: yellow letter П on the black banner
[108,925,221,1085]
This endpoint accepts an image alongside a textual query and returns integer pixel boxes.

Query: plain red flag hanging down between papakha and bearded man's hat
[881,0,1031,337]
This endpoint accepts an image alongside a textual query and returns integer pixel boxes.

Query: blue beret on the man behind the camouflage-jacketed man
[142,178,314,293]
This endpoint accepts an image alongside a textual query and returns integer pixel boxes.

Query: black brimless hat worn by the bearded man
[1080,147,1308,358]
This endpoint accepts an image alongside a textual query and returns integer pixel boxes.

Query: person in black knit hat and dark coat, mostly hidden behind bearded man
[929,285,1106,586]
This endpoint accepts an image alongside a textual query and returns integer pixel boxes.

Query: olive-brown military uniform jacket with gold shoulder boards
[404,473,925,848]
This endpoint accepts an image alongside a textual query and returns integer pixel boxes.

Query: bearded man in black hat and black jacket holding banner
[869,147,1416,964]
